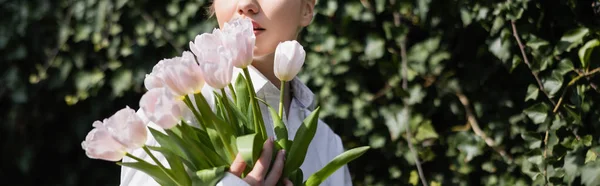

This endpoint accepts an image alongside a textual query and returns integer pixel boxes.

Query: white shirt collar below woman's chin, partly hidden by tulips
[232,66,315,110]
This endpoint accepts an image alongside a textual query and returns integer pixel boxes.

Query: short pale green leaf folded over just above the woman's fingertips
[236,133,263,167]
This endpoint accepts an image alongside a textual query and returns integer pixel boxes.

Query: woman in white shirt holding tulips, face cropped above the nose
[121,0,352,186]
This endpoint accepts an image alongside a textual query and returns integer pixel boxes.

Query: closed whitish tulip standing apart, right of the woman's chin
[273,40,306,81]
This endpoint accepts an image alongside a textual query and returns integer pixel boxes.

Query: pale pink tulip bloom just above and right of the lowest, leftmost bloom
[140,88,183,129]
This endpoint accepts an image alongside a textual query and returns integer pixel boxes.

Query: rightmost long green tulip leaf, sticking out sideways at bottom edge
[305,146,370,186]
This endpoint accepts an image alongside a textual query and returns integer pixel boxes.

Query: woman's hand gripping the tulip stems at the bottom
[229,138,293,186]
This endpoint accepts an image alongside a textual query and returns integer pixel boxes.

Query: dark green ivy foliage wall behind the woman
[0,0,600,186]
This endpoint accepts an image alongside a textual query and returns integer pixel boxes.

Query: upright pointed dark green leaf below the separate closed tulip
[283,107,320,177]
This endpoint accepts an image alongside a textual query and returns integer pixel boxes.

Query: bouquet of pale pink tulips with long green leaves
[82,19,369,186]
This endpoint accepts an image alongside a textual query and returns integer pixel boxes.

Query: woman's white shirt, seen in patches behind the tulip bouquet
[121,66,352,186]
